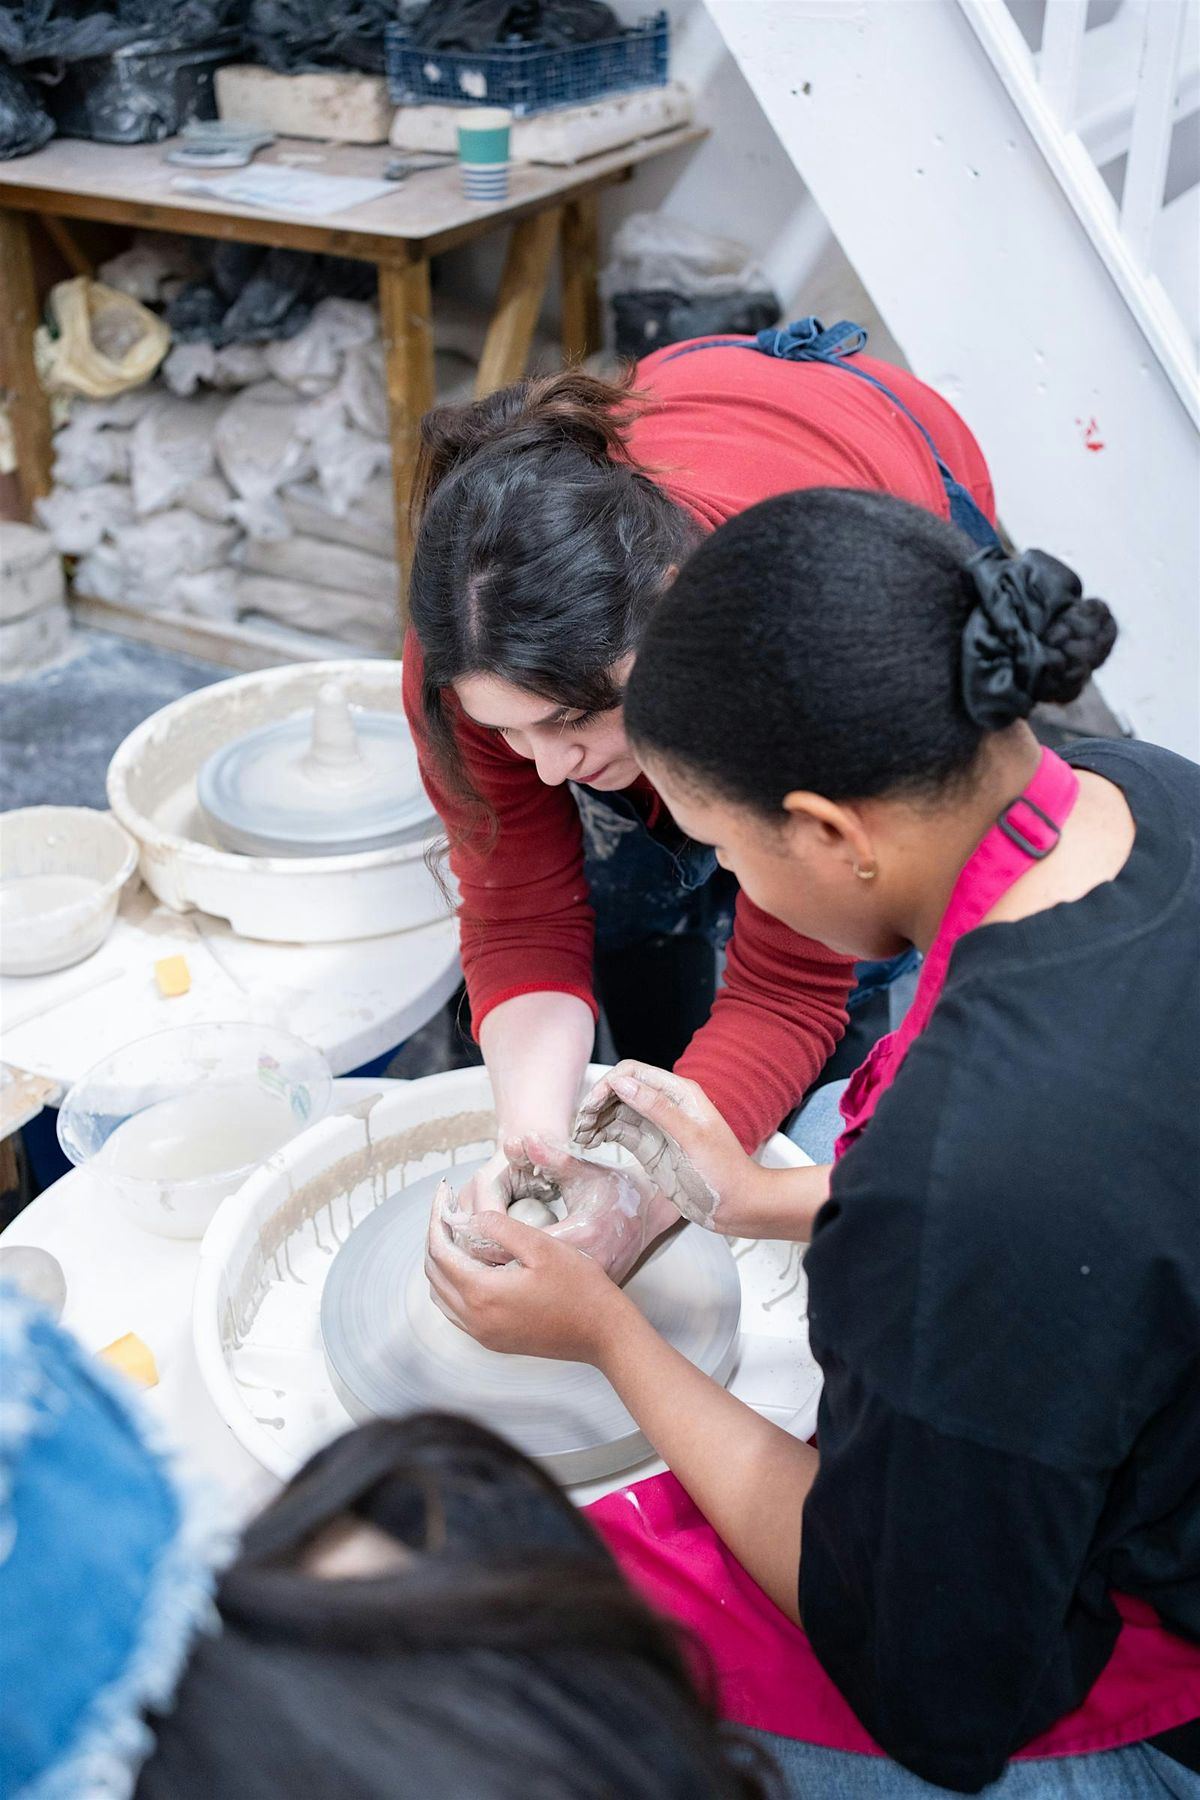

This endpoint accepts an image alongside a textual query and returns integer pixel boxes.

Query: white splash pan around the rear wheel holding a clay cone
[108,659,448,943]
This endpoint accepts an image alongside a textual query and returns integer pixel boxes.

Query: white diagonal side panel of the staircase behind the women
[709,0,1200,756]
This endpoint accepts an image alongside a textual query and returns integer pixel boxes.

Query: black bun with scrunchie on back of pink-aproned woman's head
[963,549,1117,731]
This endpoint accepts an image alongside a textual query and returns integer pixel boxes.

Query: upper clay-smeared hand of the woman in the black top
[576,1062,763,1233]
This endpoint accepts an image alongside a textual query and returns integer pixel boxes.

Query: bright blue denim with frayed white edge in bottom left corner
[0,1285,232,1800]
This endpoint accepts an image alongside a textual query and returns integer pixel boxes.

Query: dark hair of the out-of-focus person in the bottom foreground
[135,1413,775,1800]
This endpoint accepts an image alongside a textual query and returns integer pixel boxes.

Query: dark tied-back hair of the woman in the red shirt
[408,369,700,824]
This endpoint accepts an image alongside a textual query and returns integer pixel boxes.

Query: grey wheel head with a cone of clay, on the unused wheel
[196,682,434,857]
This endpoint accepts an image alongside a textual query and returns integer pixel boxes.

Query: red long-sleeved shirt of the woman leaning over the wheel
[403,349,995,1148]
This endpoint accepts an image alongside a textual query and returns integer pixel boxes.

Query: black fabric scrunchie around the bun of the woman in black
[961,545,1083,731]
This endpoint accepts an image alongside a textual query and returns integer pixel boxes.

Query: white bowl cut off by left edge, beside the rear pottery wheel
[0,806,137,976]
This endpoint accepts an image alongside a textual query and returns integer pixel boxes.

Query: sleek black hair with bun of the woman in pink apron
[624,488,1117,819]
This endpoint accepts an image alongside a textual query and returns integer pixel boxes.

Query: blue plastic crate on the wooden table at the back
[385,13,671,119]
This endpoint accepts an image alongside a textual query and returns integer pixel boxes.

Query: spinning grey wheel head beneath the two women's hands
[320,1163,741,1481]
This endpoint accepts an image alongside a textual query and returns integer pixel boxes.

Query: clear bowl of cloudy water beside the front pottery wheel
[58,1022,333,1238]
